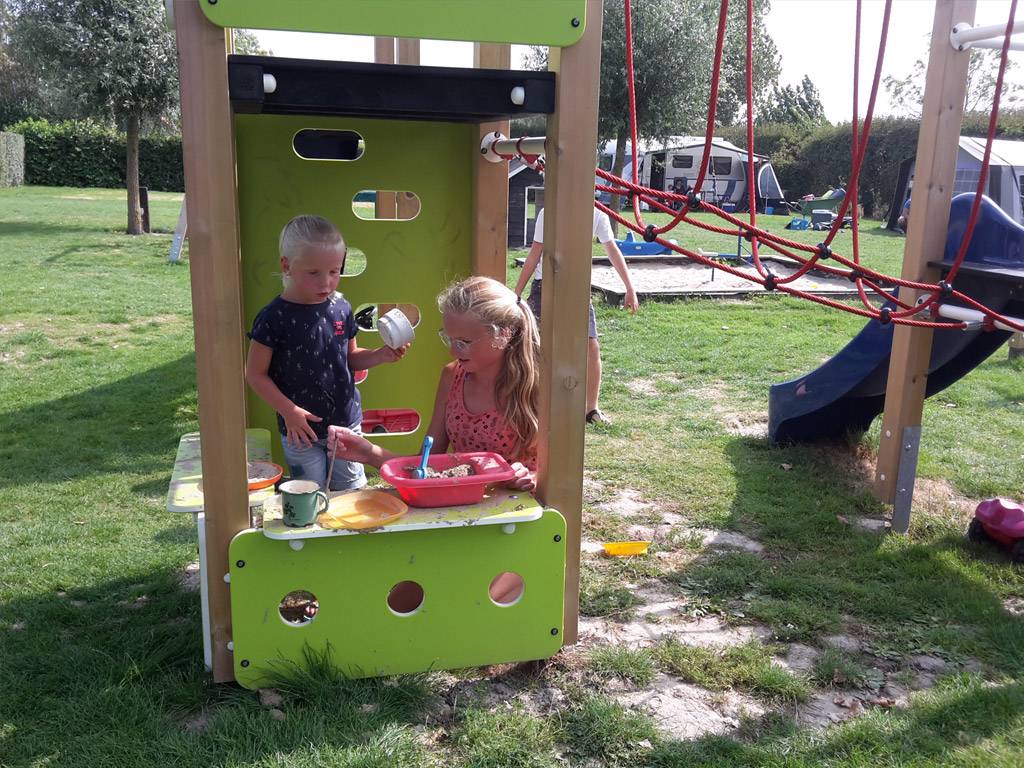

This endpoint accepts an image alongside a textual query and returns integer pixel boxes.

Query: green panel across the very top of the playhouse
[200,0,587,46]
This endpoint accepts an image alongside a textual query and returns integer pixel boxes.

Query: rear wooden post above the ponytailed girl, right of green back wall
[473,43,512,283]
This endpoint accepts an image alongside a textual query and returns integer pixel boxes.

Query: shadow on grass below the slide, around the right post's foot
[672,438,1024,676]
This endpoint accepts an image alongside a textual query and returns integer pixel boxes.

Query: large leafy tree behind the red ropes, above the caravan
[527,0,778,224]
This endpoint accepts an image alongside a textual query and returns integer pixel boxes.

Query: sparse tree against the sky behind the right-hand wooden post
[882,48,1024,118]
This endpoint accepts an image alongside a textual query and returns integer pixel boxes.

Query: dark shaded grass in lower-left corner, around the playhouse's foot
[0,570,429,768]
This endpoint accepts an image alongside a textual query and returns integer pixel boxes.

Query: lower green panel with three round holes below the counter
[229,510,565,688]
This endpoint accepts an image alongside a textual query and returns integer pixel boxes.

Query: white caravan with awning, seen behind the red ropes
[601,136,783,211]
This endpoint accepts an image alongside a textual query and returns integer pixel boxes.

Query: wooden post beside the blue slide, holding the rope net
[874,0,975,532]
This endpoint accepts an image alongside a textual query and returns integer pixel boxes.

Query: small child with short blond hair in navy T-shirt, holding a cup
[246,216,409,490]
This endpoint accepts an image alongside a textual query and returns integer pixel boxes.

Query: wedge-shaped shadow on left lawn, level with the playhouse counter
[0,354,196,493]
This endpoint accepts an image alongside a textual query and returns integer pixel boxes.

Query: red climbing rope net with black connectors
[536,0,1024,331]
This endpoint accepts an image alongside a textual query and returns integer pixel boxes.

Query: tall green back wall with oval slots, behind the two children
[234,113,479,465]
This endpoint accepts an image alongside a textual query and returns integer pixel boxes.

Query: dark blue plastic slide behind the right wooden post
[768,194,1024,443]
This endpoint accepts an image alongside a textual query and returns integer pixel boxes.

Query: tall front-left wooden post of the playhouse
[174,0,249,682]
